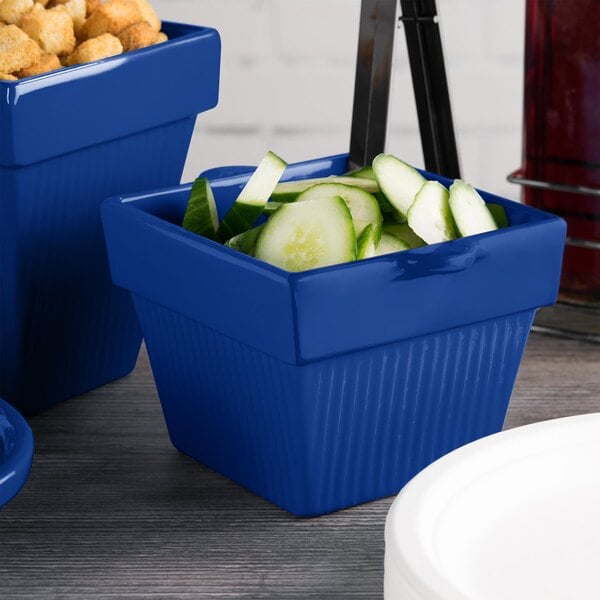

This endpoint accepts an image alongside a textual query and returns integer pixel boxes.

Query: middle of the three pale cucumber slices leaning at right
[408,181,457,244]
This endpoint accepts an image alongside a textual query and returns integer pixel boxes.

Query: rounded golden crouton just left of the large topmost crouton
[21,5,75,55]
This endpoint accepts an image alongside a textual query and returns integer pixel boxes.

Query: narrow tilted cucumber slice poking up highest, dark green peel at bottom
[217,152,287,242]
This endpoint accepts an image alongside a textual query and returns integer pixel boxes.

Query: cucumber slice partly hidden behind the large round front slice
[296,183,383,244]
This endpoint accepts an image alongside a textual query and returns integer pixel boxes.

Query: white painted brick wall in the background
[154,0,525,199]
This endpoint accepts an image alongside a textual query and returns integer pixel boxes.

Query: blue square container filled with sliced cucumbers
[103,155,565,516]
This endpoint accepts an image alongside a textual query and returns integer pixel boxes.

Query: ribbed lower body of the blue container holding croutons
[0,118,194,413]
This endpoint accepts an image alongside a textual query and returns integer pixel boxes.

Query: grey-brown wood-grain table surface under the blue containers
[0,334,600,600]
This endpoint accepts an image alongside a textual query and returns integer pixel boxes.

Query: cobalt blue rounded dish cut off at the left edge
[0,399,33,510]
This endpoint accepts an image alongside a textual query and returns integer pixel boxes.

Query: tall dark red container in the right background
[509,0,600,306]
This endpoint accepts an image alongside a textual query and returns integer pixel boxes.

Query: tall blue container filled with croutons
[0,23,220,413]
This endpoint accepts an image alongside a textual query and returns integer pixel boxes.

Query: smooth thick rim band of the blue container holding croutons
[0,22,221,167]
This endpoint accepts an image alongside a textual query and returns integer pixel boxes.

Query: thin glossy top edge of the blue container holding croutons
[0,21,216,86]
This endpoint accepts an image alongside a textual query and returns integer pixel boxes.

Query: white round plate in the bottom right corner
[385,413,600,600]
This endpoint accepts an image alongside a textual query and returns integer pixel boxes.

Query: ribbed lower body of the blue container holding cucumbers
[135,297,533,516]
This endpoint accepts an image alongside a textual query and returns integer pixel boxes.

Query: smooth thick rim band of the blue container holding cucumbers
[103,154,566,364]
